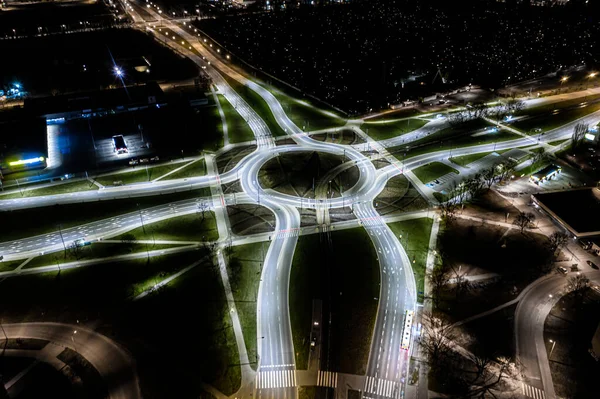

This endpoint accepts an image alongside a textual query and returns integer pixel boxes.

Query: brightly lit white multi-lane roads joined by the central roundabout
[0,3,600,399]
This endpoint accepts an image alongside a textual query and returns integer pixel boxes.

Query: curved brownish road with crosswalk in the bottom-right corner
[515,270,600,399]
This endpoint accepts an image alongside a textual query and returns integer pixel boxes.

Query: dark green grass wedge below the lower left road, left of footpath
[113,211,219,241]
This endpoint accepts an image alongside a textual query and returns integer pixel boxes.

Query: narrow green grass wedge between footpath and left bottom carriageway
[226,242,269,370]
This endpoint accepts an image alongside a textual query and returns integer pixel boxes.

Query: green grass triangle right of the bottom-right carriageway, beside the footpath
[389,218,433,303]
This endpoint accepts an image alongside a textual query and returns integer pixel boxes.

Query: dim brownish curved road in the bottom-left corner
[2,323,142,399]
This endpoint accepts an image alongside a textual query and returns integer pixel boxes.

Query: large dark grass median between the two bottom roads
[290,228,380,374]
